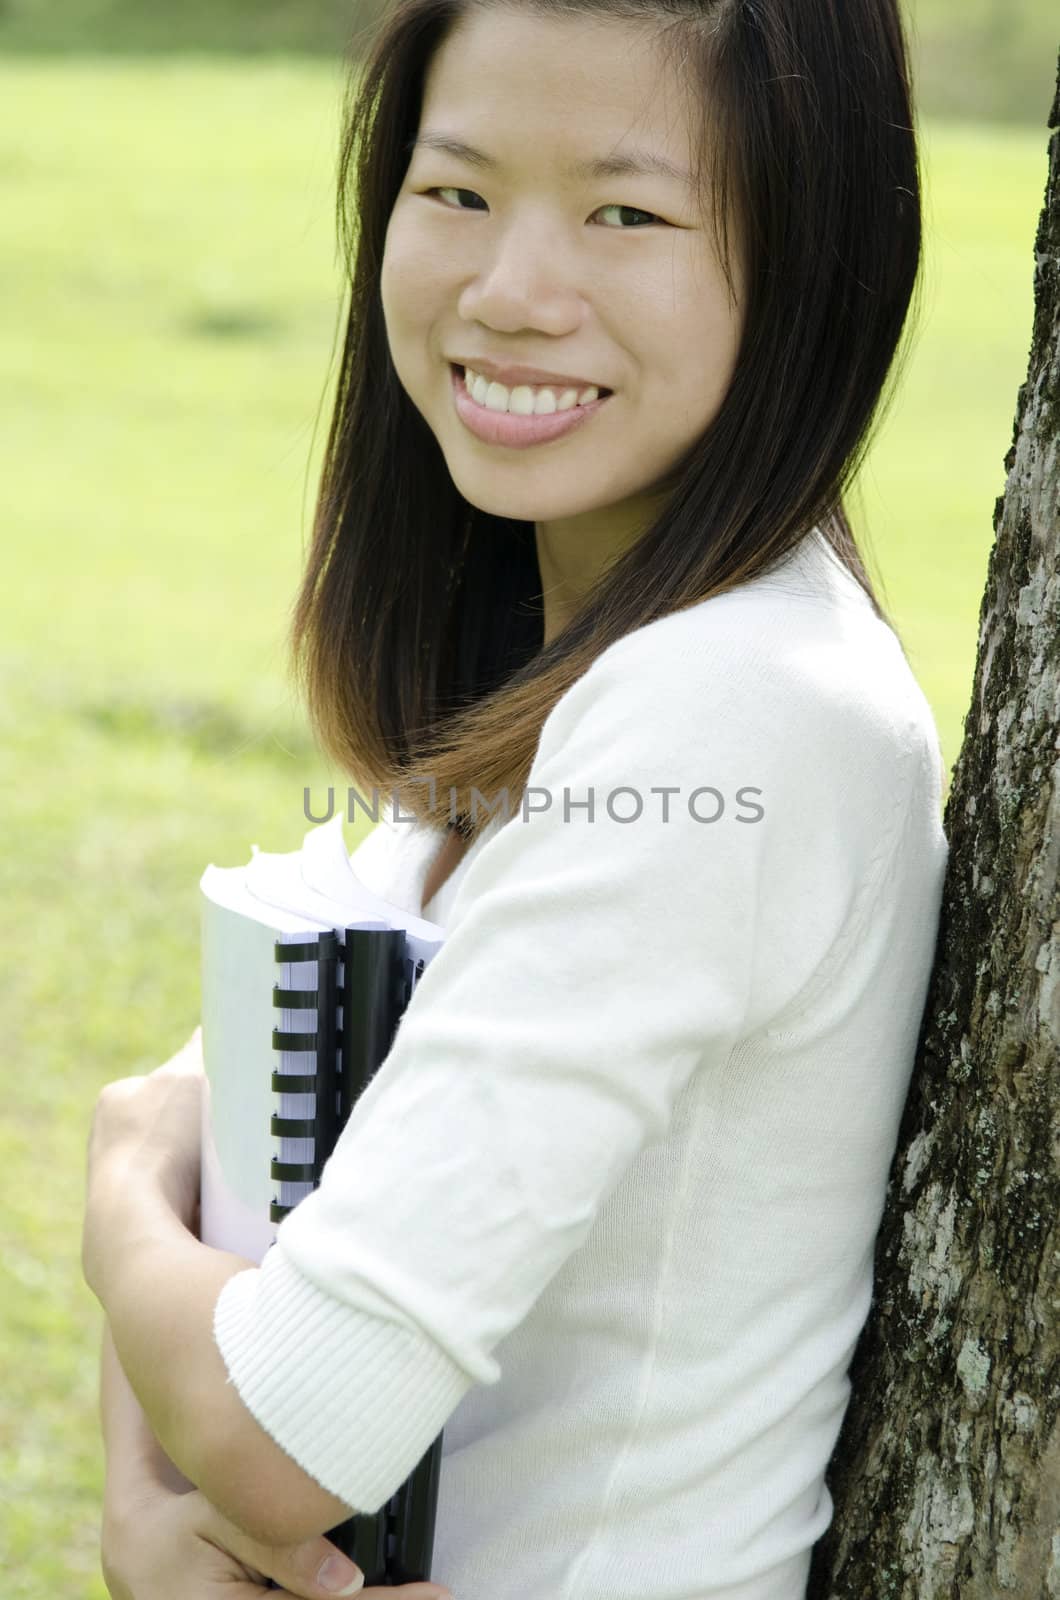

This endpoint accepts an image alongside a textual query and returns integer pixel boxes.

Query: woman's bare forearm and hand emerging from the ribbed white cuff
[82,1030,361,1544]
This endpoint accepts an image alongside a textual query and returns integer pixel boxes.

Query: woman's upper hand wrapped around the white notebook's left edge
[82,1027,207,1296]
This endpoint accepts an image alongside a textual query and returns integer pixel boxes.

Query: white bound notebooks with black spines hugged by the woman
[199,813,445,1587]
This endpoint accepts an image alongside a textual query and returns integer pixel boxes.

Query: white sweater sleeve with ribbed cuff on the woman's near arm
[215,611,914,1512]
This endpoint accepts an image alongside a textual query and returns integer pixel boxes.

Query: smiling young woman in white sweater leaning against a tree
[85,0,948,1600]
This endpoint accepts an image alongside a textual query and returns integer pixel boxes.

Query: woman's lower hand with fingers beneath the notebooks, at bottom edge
[101,1485,452,1600]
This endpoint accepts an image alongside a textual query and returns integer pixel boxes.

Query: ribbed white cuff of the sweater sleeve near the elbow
[213,1243,472,1514]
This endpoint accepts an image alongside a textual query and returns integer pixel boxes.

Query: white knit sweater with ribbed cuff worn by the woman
[215,534,948,1600]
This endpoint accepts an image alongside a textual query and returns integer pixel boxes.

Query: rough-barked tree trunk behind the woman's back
[807,50,1060,1600]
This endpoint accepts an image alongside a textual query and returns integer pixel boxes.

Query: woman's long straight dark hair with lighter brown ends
[290,0,921,840]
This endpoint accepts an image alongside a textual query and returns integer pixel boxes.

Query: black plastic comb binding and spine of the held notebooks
[269,928,444,1589]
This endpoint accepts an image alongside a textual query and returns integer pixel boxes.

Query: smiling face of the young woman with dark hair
[381,6,740,549]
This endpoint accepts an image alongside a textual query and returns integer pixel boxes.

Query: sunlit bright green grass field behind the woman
[0,56,1046,1600]
